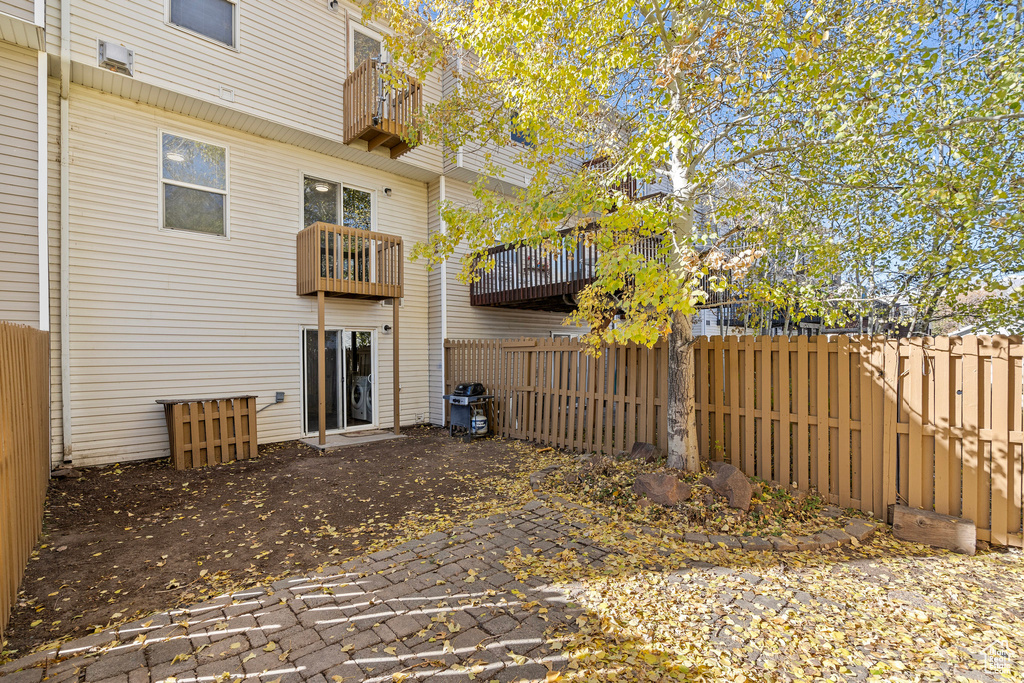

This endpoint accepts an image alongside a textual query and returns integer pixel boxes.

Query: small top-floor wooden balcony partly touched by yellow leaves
[344,59,423,159]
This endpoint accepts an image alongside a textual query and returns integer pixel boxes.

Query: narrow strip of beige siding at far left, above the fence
[0,43,39,328]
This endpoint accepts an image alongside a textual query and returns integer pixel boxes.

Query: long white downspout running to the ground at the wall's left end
[60,0,72,462]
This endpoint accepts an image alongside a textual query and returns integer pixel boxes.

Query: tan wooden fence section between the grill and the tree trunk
[444,338,669,453]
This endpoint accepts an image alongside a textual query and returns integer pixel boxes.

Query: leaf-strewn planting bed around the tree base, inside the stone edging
[548,458,866,537]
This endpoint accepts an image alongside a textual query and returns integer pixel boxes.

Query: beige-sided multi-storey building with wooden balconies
[0,0,585,465]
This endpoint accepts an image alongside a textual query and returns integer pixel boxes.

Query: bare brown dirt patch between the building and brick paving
[0,427,552,659]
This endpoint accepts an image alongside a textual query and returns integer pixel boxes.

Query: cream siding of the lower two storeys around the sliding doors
[60,87,428,465]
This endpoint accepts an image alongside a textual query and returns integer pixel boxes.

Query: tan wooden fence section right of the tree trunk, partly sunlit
[695,336,1024,546]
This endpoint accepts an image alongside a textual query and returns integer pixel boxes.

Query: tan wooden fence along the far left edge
[0,323,50,637]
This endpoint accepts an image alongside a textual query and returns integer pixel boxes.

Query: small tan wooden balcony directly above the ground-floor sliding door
[296,223,404,299]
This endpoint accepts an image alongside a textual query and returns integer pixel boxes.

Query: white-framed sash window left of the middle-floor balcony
[160,133,227,236]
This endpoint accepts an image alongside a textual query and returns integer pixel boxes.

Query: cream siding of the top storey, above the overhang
[61,0,441,172]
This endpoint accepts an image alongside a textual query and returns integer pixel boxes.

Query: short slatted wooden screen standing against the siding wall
[157,396,256,470]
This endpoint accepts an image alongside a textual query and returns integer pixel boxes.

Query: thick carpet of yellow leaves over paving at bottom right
[520,464,1024,681]
